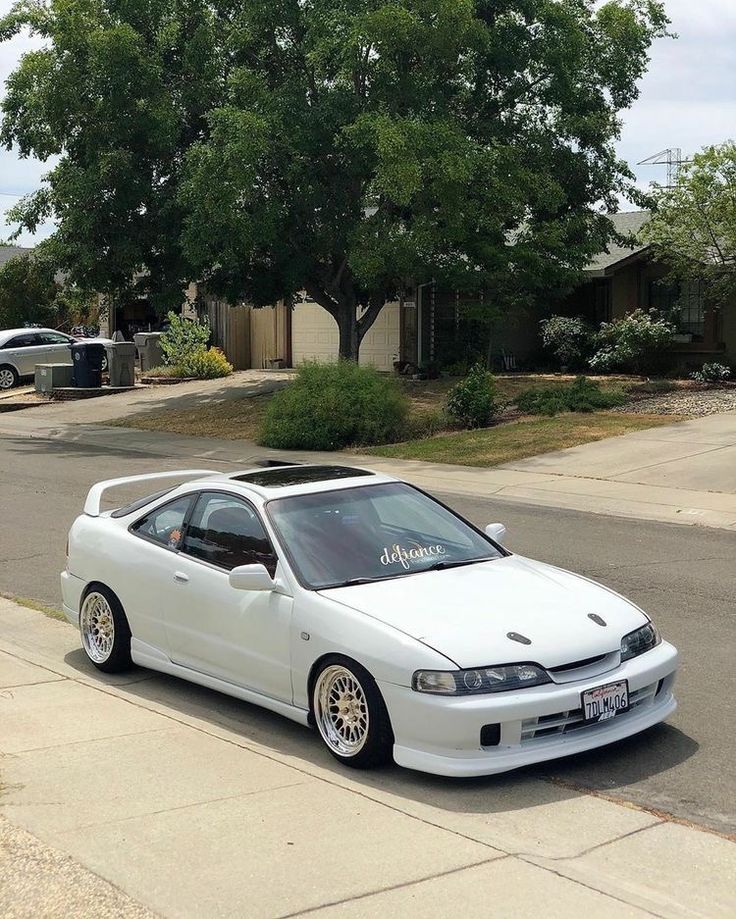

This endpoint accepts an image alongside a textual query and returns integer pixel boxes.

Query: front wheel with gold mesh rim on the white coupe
[312,655,394,769]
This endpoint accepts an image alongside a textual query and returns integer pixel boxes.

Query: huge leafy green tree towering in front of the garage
[0,0,667,359]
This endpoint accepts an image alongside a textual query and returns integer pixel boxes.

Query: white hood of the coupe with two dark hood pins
[320,555,647,667]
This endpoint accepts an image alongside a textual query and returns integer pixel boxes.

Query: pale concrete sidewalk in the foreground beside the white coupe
[0,600,736,917]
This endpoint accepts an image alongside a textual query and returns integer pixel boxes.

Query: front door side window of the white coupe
[182,492,277,577]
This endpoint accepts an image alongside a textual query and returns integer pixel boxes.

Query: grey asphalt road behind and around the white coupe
[0,436,736,833]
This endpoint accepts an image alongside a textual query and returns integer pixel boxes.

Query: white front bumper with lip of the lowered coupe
[379,642,678,777]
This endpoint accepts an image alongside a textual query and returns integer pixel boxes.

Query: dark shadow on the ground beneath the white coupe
[65,648,698,814]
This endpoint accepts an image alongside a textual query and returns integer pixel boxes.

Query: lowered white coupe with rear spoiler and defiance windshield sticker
[61,464,677,776]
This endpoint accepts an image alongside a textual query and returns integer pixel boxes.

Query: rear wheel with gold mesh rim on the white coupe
[79,585,133,673]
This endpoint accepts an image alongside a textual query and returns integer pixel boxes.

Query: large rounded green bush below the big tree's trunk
[260,361,409,450]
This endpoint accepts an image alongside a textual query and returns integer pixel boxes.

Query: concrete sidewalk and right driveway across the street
[0,406,736,530]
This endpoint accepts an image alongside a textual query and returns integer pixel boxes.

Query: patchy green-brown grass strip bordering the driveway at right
[361,412,685,466]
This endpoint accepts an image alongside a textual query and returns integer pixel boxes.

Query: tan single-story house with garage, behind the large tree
[103,211,736,371]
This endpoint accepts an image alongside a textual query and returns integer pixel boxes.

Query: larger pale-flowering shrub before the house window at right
[588,310,675,373]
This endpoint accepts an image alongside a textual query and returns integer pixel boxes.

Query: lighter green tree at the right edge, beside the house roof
[642,141,736,308]
